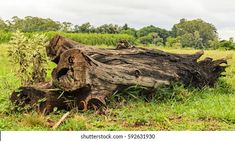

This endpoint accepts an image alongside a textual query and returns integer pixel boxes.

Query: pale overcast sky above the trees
[0,0,235,39]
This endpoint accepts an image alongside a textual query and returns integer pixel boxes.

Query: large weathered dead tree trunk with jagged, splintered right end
[12,36,227,112]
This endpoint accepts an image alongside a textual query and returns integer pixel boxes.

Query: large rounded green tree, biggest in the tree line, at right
[172,19,218,48]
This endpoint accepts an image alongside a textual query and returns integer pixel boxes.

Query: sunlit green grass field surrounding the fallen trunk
[0,44,235,130]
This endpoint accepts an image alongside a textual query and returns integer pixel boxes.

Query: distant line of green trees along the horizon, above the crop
[0,16,235,49]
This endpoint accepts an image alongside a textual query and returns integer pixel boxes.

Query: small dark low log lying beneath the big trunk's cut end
[10,82,102,115]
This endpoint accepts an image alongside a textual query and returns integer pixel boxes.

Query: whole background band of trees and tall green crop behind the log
[0,16,235,50]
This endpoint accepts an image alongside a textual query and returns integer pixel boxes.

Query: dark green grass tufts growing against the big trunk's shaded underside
[109,83,190,106]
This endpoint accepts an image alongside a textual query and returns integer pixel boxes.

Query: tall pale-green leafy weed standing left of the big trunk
[8,31,47,85]
